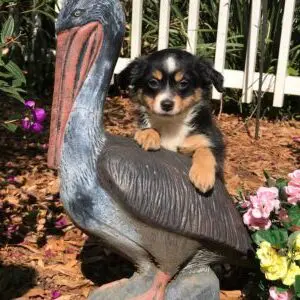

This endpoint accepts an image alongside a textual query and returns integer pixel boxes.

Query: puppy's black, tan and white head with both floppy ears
[117,49,223,116]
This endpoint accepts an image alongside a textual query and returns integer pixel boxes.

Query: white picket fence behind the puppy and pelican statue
[56,0,300,107]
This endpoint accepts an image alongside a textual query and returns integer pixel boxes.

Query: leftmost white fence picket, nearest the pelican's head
[130,0,143,59]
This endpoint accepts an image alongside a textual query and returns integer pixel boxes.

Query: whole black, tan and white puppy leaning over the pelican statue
[116,49,224,193]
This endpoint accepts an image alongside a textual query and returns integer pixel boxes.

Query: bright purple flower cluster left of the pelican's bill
[21,100,46,133]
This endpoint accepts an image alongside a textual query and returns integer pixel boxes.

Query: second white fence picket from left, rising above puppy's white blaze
[158,0,171,50]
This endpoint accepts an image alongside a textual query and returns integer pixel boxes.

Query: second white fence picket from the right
[242,0,265,103]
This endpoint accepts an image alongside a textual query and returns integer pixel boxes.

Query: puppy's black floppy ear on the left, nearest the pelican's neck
[116,58,147,90]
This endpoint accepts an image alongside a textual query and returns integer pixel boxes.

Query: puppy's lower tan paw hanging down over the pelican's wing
[189,163,215,193]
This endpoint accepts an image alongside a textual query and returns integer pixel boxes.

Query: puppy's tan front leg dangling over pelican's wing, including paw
[179,134,217,193]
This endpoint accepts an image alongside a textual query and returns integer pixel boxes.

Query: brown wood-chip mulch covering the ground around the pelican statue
[0,98,300,300]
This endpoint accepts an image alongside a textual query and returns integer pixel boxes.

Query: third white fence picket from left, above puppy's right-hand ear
[186,0,200,54]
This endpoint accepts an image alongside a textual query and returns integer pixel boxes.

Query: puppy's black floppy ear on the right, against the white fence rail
[196,58,224,92]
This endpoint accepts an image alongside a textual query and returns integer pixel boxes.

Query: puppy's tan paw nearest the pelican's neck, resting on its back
[134,128,160,151]
